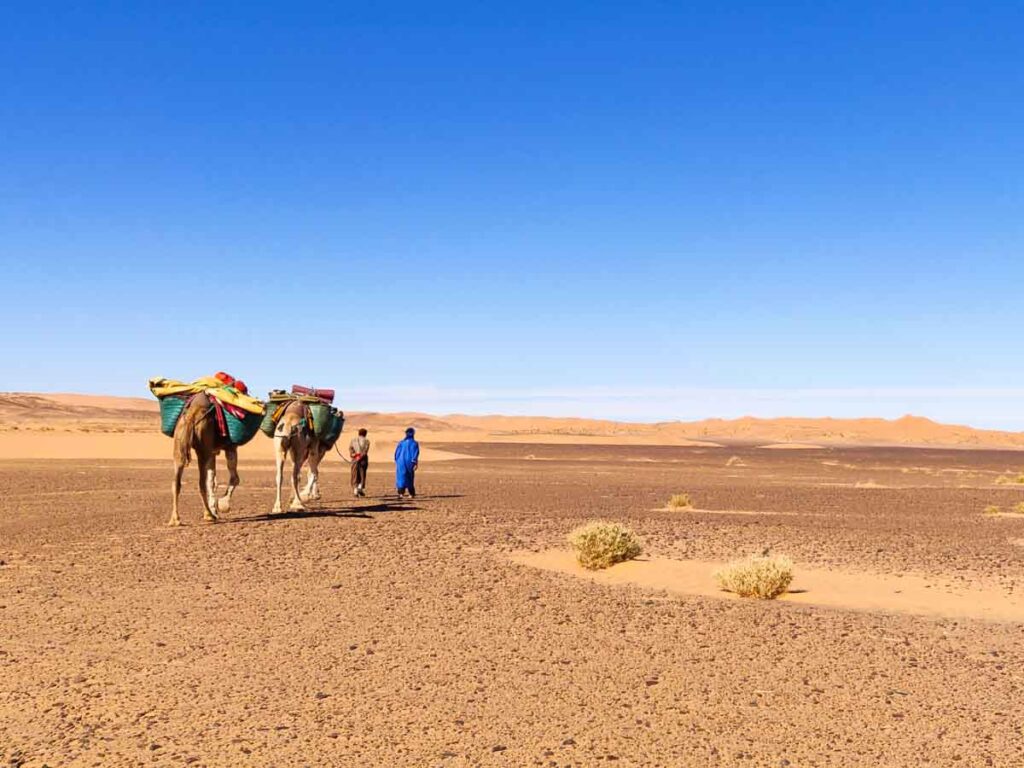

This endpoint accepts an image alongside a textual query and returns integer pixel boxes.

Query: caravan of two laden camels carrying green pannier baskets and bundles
[150,372,345,525]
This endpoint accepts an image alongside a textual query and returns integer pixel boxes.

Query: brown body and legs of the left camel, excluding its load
[169,393,239,525]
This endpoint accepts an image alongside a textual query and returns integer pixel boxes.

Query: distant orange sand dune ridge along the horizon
[0,392,1024,454]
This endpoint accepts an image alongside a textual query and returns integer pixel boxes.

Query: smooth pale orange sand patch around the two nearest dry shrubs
[513,550,1024,622]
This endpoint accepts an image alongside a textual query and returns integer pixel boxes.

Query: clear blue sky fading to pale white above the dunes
[0,1,1024,429]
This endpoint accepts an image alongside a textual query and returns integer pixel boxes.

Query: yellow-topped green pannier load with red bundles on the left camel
[150,372,265,445]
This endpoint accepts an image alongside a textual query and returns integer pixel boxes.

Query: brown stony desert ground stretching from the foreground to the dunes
[0,401,1024,768]
